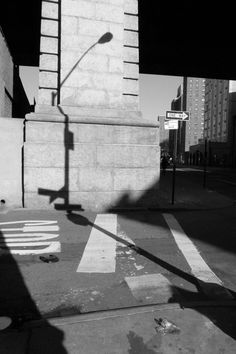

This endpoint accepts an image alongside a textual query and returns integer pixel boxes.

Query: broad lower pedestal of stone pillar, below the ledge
[24,121,159,211]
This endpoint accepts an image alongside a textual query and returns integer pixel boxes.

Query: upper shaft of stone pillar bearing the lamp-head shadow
[38,0,139,110]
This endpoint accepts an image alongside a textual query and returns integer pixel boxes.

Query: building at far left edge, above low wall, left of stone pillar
[0,27,31,118]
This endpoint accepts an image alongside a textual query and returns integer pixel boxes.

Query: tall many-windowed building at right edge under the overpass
[190,79,236,167]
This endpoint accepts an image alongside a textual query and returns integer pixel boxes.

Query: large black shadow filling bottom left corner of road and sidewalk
[0,231,67,354]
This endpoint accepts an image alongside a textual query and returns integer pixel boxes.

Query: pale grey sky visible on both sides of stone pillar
[20,66,183,117]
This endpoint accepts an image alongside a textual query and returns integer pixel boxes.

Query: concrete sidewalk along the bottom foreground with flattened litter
[0,302,236,354]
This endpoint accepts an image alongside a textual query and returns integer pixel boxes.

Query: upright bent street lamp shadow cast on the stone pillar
[38,32,113,210]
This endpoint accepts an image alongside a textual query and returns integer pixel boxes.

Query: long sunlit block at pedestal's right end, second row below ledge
[97,145,159,168]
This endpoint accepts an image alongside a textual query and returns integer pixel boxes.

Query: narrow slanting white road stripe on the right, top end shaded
[163,214,222,285]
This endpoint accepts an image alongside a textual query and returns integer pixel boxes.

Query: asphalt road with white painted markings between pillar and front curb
[0,195,236,317]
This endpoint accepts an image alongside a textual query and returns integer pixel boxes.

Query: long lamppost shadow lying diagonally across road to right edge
[67,212,236,339]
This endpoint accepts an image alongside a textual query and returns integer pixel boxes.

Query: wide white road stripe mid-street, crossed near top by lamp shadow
[77,214,117,273]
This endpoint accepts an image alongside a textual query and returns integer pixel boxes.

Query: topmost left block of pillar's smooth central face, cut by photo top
[61,0,96,18]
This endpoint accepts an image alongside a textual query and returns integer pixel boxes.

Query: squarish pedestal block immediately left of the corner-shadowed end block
[78,168,113,192]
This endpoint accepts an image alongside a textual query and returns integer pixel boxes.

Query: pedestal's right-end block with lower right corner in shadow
[114,166,159,191]
